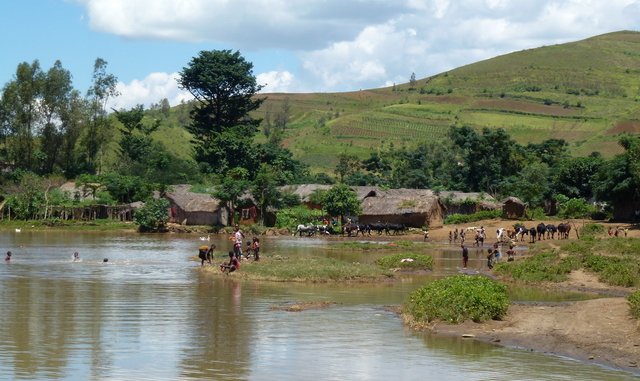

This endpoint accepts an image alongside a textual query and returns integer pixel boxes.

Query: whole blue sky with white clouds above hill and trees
[0,0,640,109]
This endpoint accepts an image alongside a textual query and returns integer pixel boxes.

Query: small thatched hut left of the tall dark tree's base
[165,184,228,225]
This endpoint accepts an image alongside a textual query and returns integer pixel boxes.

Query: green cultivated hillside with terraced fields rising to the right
[149,31,640,171]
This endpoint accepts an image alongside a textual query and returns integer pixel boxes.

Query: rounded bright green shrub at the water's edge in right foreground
[405,275,509,323]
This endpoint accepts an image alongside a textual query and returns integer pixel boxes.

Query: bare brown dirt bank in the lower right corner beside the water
[420,297,640,375]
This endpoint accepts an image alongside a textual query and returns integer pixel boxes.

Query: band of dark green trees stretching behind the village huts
[0,50,640,223]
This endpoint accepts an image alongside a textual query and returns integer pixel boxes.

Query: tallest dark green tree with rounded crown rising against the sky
[178,50,264,174]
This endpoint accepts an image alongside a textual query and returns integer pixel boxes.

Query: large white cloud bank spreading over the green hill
[75,0,640,95]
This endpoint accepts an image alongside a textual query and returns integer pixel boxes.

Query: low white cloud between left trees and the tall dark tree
[108,73,193,110]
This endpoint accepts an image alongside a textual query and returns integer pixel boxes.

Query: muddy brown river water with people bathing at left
[0,230,636,380]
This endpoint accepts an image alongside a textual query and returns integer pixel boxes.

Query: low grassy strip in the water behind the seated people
[236,257,393,283]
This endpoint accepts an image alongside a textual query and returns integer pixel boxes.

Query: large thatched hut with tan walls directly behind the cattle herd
[359,187,445,228]
